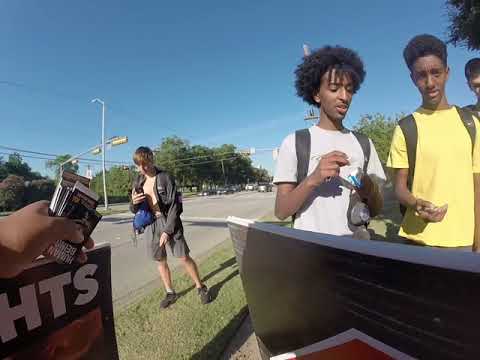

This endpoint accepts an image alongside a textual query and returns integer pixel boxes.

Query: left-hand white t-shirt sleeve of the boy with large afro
[273,134,297,184]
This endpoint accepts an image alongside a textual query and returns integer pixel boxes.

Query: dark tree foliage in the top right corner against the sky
[446,0,480,50]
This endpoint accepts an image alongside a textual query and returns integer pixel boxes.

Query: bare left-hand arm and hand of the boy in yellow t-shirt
[395,169,447,222]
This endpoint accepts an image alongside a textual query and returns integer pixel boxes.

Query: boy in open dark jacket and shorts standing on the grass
[130,146,211,308]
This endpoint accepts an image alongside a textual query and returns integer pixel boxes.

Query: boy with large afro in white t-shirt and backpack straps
[274,46,385,236]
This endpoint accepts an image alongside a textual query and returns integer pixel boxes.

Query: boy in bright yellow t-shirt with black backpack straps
[387,35,480,250]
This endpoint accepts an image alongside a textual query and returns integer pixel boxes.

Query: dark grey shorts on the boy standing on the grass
[144,216,190,261]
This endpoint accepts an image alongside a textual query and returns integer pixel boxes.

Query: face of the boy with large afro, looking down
[313,69,353,122]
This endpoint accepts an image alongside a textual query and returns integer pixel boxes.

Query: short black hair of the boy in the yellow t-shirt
[403,34,447,71]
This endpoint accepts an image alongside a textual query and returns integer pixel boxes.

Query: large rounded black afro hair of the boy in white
[295,46,365,106]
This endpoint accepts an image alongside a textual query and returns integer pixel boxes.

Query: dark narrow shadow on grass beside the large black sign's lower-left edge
[191,306,248,360]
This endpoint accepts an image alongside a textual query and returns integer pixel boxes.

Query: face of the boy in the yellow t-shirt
[411,55,449,108]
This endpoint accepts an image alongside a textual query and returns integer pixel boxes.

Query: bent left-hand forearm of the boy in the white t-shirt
[275,177,316,220]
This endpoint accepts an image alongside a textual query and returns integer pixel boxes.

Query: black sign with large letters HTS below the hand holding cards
[0,245,118,360]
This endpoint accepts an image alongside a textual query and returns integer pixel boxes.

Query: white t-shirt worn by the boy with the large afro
[273,126,386,235]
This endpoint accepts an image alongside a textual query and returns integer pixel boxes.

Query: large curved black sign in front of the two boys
[229,218,480,359]
